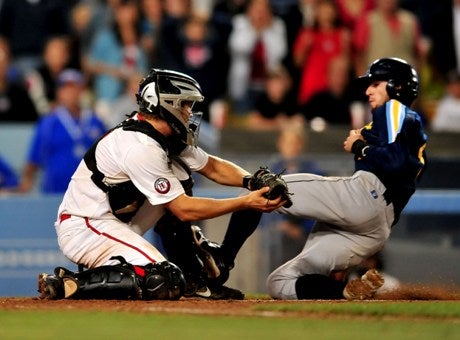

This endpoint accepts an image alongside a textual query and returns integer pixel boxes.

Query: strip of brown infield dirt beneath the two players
[0,286,460,315]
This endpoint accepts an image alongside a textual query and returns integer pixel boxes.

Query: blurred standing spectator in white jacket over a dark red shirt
[228,0,287,114]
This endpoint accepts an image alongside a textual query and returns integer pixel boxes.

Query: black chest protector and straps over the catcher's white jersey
[84,119,193,223]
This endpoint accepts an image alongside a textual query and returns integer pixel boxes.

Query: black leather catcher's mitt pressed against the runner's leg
[243,167,292,208]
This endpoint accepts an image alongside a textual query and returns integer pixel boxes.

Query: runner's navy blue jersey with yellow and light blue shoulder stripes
[355,100,427,223]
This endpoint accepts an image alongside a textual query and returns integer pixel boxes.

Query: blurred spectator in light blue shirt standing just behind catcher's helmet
[87,0,148,119]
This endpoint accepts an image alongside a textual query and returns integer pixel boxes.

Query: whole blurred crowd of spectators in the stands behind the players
[0,0,460,192]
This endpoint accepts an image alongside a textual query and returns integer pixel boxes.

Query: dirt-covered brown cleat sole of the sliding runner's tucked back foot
[343,269,384,300]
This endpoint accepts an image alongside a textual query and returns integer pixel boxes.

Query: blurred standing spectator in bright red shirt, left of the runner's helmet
[292,0,351,105]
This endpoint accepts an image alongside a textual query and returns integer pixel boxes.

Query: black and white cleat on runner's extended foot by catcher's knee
[192,225,232,285]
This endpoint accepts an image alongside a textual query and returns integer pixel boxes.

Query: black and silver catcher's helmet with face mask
[136,68,204,145]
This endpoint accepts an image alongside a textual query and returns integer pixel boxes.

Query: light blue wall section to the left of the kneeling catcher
[0,195,74,296]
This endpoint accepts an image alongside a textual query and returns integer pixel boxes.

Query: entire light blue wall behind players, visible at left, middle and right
[0,189,460,296]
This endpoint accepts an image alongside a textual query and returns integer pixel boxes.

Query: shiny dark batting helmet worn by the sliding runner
[358,58,419,106]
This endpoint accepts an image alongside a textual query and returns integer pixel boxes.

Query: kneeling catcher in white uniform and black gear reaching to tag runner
[38,69,288,300]
